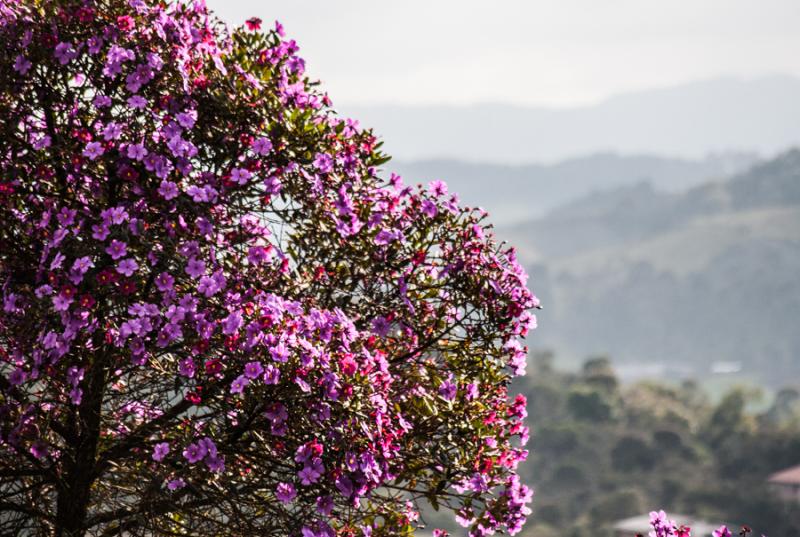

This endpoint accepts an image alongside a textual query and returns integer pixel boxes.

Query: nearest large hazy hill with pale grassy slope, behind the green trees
[500,150,800,385]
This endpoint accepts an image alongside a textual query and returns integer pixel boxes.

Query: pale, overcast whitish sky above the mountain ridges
[202,0,800,107]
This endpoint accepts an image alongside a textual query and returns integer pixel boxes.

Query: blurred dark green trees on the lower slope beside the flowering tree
[517,353,800,537]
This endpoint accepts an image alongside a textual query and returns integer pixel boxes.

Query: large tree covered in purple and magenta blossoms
[0,0,538,537]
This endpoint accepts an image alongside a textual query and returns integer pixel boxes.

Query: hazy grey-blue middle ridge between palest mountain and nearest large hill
[394,152,757,225]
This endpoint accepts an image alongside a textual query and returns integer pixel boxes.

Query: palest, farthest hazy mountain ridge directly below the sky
[341,76,800,164]
